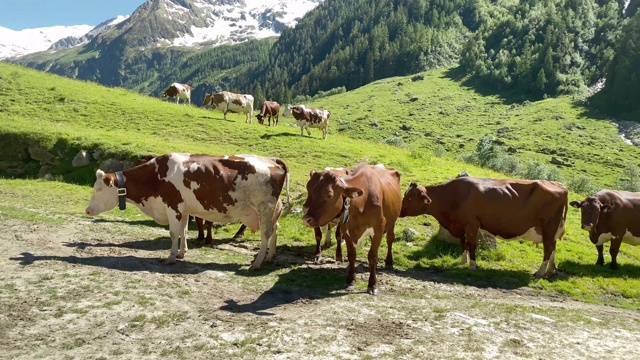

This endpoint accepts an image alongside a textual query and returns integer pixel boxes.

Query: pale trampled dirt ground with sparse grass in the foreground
[0,219,640,359]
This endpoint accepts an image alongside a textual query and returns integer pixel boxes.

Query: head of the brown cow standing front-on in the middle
[302,170,364,227]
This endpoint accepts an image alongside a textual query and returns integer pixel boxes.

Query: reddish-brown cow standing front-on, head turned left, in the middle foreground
[302,163,402,295]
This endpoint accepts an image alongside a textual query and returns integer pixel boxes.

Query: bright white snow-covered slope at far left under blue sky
[0,25,93,59]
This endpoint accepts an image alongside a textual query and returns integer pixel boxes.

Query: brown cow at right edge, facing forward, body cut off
[570,190,640,269]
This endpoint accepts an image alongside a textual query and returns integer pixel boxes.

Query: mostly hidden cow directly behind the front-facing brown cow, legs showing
[302,168,349,261]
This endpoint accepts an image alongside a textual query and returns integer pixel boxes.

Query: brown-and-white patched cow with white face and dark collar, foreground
[86,153,289,269]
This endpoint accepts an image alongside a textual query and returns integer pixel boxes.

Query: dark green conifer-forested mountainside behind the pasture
[8,0,640,114]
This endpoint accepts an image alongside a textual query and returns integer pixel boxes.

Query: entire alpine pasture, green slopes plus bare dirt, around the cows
[0,64,640,358]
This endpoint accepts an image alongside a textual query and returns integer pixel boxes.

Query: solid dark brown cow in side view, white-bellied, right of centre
[400,177,568,277]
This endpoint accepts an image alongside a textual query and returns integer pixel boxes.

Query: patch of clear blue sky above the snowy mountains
[0,0,145,30]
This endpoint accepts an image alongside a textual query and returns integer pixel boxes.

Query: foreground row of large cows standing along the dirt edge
[86,149,640,294]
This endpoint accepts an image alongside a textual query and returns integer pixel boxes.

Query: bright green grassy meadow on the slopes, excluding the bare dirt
[0,63,640,309]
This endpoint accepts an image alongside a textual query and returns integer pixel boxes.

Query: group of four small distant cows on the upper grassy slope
[162,83,331,139]
